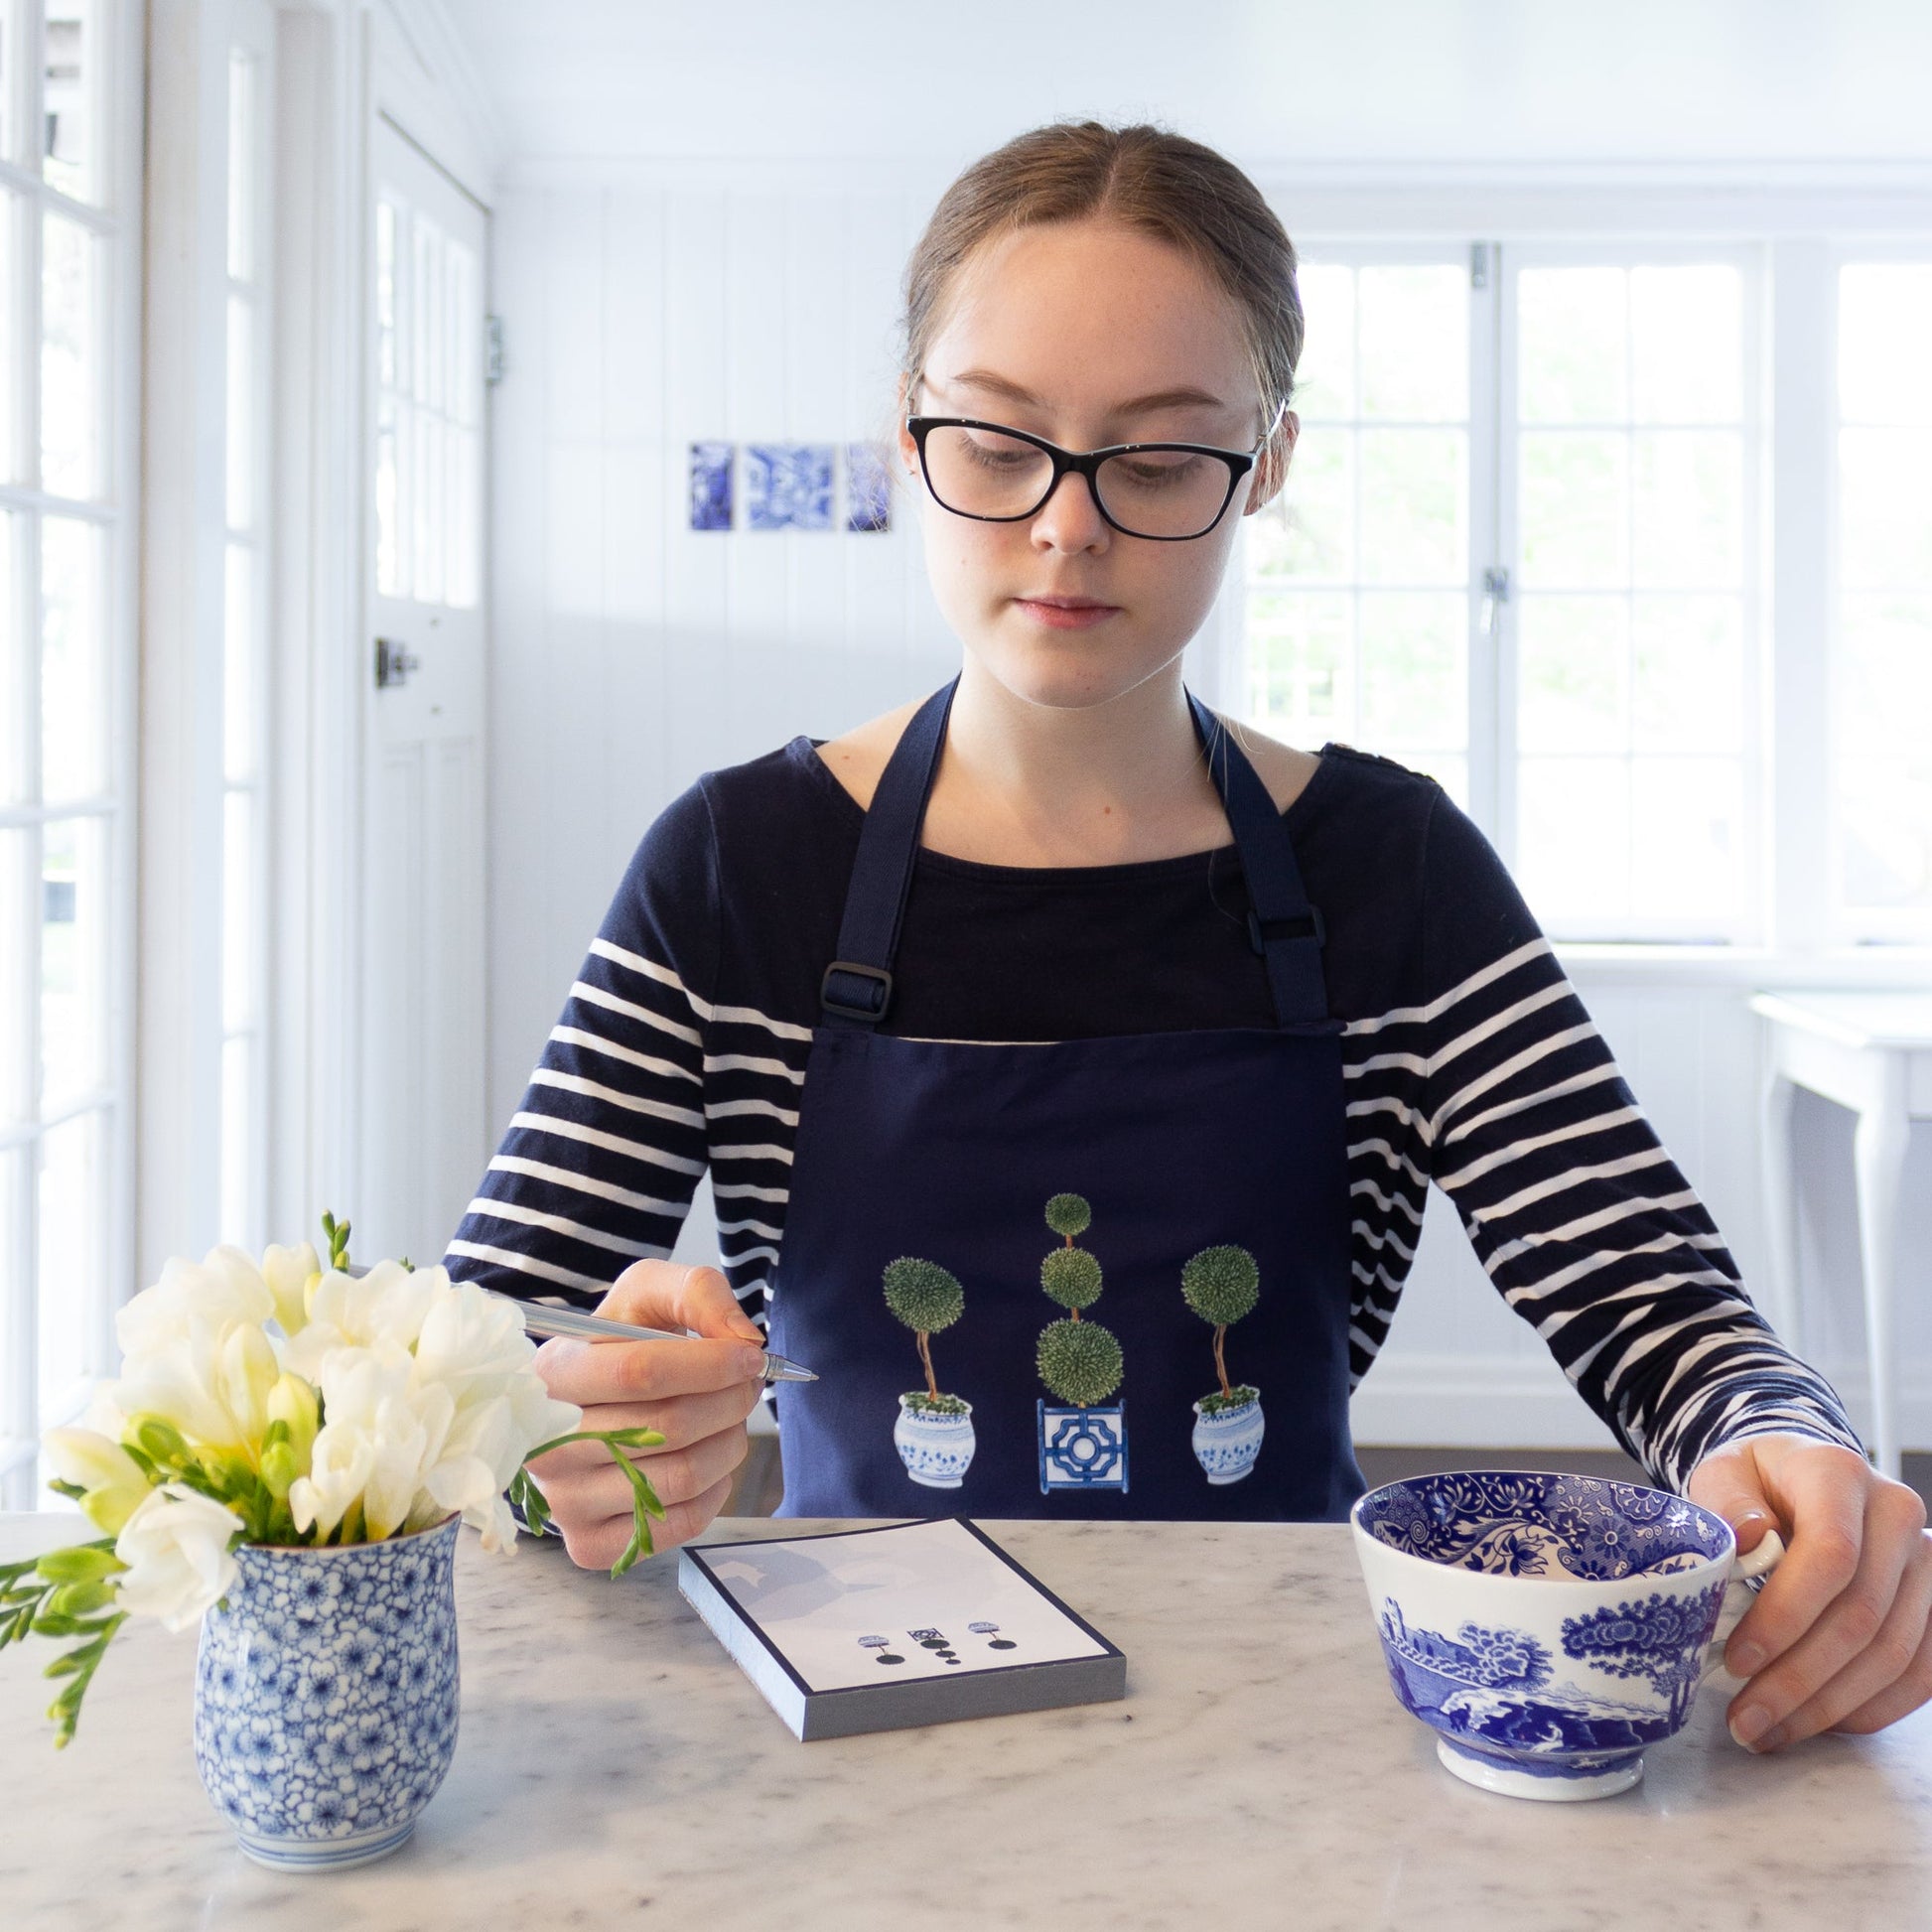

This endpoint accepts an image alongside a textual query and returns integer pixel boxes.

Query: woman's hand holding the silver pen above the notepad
[527,1262,765,1569]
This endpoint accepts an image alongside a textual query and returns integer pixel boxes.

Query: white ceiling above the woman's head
[437,0,1932,174]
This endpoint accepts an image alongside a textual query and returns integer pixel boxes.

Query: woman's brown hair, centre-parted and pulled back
[889,120,1303,480]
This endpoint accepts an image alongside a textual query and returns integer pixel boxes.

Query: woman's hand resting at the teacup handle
[1685,1436,1932,1750]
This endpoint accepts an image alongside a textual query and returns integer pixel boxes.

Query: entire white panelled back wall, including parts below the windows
[488,180,1932,1448]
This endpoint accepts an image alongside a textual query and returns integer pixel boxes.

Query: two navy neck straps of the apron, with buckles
[819,674,1327,1028]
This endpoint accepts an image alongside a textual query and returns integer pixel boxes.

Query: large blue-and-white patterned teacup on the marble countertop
[1348,1470,1783,1799]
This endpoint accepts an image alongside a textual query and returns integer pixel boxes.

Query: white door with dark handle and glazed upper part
[349,120,488,1264]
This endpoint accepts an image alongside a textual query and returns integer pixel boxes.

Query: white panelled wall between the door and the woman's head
[488,186,958,1127]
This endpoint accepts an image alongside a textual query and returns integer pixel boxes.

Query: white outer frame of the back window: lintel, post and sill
[1228,178,1932,987]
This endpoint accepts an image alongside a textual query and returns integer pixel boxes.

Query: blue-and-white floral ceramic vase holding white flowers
[196,1517,458,1872]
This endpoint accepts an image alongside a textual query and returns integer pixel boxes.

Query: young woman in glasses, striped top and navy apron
[448,122,1932,1748]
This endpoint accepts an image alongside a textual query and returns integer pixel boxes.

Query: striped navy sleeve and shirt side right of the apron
[1346,798,1863,1489]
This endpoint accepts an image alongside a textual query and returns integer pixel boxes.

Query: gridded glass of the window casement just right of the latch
[1513,263,1756,941]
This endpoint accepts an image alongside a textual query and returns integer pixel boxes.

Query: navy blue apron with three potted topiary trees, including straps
[770,678,1366,1522]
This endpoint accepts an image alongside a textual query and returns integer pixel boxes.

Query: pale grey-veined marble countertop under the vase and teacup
[0,1517,1932,1932]
